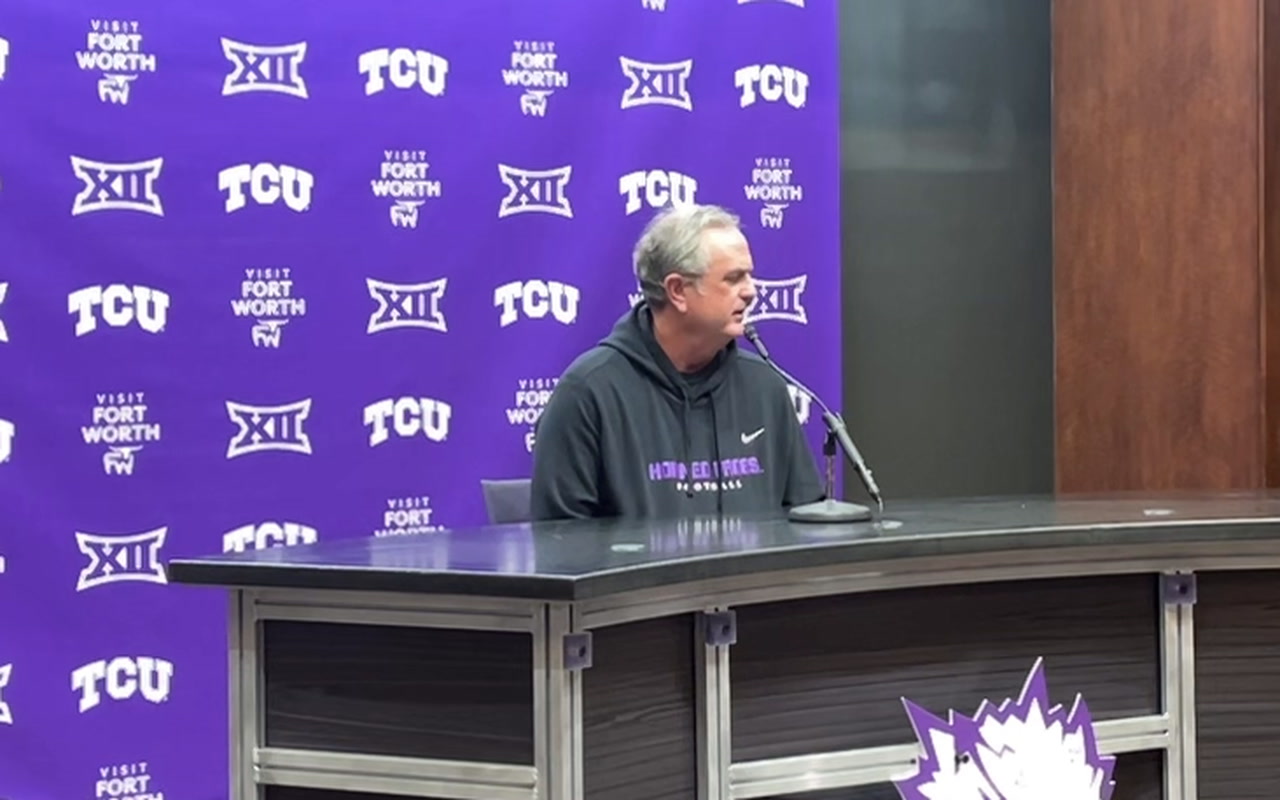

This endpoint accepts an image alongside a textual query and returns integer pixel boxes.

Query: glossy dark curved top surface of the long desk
[168,492,1280,600]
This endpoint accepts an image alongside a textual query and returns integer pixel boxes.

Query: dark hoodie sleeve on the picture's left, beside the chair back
[530,379,600,521]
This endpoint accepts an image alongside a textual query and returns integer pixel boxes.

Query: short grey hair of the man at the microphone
[631,205,739,308]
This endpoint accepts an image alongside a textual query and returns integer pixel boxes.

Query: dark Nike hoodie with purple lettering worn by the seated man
[532,302,824,520]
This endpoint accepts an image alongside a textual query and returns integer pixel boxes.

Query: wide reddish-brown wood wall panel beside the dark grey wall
[1053,0,1280,492]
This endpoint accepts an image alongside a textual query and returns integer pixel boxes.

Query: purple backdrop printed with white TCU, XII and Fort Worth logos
[0,0,840,800]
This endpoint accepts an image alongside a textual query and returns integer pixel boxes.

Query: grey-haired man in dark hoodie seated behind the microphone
[531,205,824,520]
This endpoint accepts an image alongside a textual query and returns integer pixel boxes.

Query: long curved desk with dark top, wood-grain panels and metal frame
[169,493,1280,800]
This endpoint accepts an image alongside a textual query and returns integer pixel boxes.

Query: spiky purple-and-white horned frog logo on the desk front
[895,659,1115,800]
